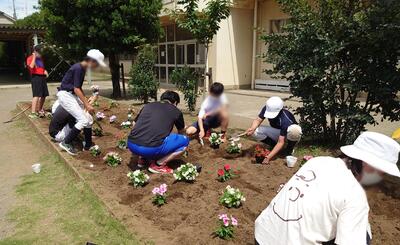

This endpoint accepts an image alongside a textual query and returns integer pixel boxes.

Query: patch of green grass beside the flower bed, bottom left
[0,147,140,245]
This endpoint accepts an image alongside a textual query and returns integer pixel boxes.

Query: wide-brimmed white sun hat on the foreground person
[340,132,400,177]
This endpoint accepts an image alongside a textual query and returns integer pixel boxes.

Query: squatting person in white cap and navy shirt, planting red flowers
[246,96,302,164]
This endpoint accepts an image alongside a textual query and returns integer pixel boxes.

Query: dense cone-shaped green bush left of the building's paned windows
[129,45,160,103]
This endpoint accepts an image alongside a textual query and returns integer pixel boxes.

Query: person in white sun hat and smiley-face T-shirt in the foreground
[255,132,400,245]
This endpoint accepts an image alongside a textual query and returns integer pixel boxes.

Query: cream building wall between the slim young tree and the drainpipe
[209,8,253,88]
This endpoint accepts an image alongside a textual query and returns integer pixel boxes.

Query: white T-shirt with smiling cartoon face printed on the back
[255,157,369,245]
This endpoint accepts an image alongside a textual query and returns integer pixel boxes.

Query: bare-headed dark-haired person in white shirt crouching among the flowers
[186,83,229,139]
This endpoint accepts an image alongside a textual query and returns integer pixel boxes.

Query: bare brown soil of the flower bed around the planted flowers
[29,98,400,244]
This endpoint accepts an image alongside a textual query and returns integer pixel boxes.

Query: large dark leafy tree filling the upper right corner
[263,0,400,143]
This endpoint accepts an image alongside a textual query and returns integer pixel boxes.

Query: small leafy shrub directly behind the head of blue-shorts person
[171,66,199,112]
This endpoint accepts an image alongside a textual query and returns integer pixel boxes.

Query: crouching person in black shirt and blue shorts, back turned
[128,91,189,174]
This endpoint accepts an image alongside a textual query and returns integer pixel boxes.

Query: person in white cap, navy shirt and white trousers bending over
[57,49,106,155]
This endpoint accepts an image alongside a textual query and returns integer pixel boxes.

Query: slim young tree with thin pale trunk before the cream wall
[172,0,231,88]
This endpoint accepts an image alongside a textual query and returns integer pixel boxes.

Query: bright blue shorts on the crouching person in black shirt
[128,134,189,160]
